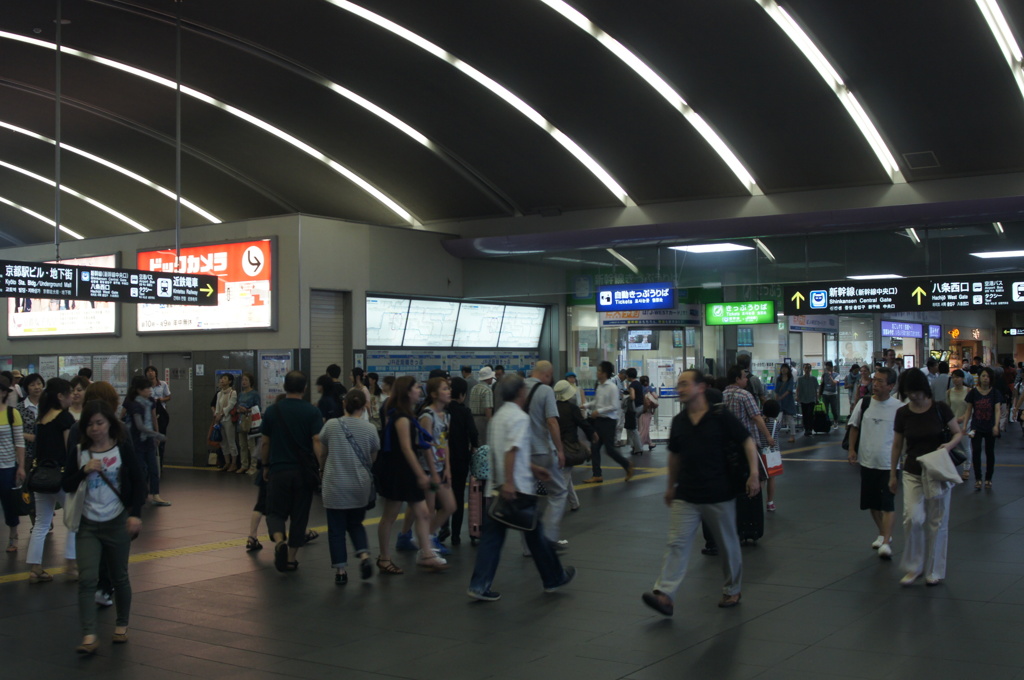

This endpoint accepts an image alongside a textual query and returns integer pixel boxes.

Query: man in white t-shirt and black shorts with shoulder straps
[848,368,903,559]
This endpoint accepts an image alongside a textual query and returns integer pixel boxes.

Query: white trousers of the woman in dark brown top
[901,471,950,580]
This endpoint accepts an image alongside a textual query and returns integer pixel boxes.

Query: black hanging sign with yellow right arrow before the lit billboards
[0,260,217,305]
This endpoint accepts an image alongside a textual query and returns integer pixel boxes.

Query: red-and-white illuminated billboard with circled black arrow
[137,239,274,333]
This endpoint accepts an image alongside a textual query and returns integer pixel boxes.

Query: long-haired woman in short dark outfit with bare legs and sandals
[374,376,449,573]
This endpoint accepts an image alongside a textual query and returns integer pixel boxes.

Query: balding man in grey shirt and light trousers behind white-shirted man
[523,362,568,548]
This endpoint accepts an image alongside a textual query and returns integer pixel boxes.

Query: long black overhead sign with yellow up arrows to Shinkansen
[782,272,1024,314]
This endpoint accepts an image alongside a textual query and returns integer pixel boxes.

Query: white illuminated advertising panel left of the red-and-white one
[7,255,118,339]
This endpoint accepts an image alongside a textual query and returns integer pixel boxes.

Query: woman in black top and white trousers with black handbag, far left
[25,378,78,583]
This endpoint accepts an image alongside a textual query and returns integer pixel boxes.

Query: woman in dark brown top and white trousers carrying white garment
[889,369,964,586]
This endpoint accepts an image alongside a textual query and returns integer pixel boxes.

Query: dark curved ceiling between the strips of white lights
[0,0,1024,251]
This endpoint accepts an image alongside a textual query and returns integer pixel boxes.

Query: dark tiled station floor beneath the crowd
[0,432,1024,680]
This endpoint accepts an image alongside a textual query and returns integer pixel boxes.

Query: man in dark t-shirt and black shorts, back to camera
[260,371,324,571]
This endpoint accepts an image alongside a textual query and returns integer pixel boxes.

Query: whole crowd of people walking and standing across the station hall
[0,356,1024,654]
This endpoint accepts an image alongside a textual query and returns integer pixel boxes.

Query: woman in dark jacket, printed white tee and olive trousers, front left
[62,399,146,654]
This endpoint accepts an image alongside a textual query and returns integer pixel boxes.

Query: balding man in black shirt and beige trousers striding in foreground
[643,370,761,617]
